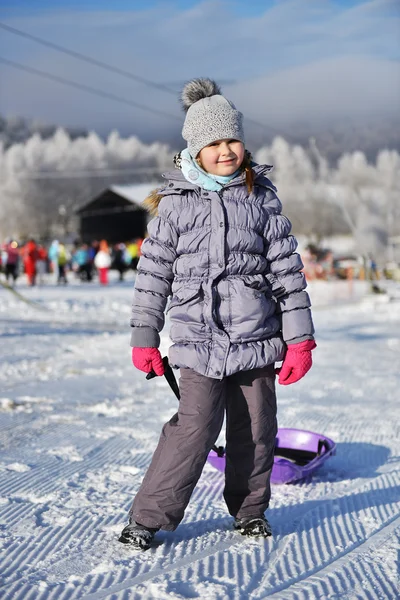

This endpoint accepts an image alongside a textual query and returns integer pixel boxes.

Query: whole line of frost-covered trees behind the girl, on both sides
[0,129,400,260]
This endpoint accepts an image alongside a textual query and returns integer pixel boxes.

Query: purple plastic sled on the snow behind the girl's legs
[208,428,336,483]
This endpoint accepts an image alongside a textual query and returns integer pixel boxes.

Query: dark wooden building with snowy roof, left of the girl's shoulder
[77,182,160,244]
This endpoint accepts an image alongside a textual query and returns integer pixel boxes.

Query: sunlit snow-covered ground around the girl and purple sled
[0,274,400,600]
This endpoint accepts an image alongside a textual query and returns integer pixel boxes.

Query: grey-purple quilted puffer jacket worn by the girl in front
[131,165,314,379]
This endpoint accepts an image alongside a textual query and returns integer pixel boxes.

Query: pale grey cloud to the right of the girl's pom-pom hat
[229,56,400,122]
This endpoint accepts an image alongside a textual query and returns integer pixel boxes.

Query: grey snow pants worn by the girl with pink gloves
[129,365,277,531]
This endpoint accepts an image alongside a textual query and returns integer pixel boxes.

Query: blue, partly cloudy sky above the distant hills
[0,0,400,141]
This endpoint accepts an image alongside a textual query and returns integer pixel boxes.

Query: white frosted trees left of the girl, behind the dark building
[0,129,172,238]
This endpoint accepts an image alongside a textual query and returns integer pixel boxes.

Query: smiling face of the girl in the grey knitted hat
[198,140,244,176]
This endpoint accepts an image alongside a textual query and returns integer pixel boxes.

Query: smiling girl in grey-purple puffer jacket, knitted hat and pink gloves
[120,79,315,549]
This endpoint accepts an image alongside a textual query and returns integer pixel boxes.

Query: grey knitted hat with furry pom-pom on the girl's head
[181,78,244,158]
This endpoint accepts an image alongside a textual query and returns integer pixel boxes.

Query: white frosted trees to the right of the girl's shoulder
[256,138,400,262]
